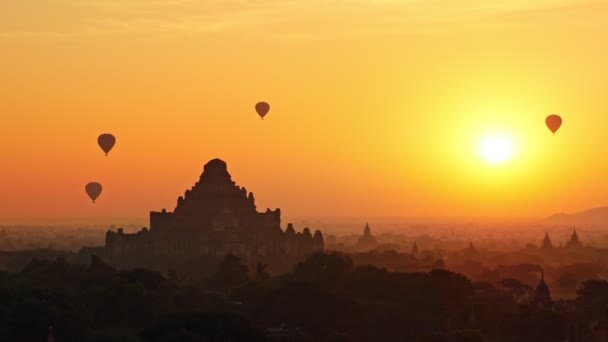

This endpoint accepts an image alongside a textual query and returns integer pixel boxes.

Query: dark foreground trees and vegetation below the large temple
[0,253,608,342]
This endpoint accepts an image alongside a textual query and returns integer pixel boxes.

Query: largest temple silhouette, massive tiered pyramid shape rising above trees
[105,159,324,270]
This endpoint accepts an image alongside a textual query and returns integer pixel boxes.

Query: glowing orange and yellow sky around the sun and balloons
[0,0,608,223]
